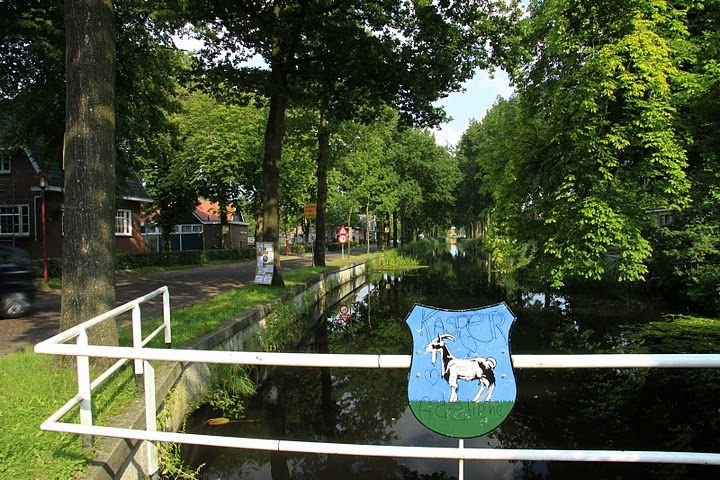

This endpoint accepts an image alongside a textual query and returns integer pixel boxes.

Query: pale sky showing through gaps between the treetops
[175,37,513,147]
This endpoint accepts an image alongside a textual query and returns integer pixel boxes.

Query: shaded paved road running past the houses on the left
[0,252,348,355]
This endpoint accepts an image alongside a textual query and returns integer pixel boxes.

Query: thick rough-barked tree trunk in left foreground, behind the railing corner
[60,0,118,345]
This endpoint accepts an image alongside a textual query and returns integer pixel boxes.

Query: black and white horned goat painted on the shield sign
[425,333,497,403]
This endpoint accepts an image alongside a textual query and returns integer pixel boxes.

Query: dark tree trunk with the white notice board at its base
[262,64,287,287]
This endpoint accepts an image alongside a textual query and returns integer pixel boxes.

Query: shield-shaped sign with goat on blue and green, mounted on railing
[405,303,517,438]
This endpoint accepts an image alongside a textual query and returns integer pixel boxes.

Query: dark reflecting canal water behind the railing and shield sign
[183,249,720,480]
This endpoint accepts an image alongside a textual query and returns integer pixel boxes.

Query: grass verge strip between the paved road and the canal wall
[0,254,402,479]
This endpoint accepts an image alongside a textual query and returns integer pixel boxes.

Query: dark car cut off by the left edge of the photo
[0,245,36,318]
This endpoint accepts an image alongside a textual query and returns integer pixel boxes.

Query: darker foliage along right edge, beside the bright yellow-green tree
[652,1,720,312]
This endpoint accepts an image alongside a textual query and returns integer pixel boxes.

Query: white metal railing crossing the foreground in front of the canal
[35,287,720,478]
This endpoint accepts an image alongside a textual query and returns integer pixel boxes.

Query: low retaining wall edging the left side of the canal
[87,263,367,480]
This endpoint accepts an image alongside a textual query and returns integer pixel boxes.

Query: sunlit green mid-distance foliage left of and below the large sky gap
[328,114,461,244]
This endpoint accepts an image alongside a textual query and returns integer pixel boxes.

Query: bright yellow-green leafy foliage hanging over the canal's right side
[461,0,716,287]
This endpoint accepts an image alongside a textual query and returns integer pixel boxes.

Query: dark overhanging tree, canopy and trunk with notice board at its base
[183,0,507,284]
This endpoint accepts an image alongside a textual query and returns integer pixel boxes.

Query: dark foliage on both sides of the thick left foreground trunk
[0,0,183,172]
